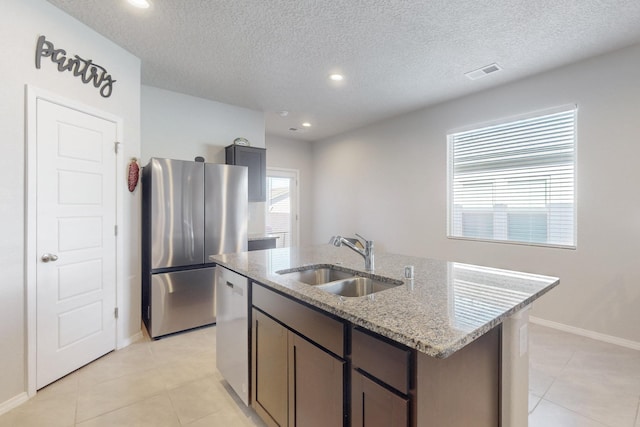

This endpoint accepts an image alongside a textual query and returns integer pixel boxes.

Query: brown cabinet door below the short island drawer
[351,371,409,427]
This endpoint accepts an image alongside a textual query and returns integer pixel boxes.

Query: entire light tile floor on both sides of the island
[0,324,640,427]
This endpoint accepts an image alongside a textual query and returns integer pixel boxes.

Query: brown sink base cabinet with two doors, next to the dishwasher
[251,284,347,427]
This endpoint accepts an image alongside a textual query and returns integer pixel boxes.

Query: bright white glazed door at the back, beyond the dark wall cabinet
[265,168,298,248]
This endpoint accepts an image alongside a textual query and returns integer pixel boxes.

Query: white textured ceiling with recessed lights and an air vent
[48,0,640,140]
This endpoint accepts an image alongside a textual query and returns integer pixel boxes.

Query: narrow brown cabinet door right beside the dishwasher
[252,309,288,426]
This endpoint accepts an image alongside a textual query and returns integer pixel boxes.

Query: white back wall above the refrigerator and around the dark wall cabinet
[141,86,268,234]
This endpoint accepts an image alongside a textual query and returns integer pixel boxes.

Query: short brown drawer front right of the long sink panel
[351,328,411,394]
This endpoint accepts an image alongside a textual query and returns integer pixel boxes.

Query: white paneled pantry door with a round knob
[36,99,117,389]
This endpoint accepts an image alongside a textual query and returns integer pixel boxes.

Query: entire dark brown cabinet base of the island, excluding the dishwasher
[245,282,500,427]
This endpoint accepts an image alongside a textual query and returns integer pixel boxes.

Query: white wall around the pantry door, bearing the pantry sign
[0,0,140,406]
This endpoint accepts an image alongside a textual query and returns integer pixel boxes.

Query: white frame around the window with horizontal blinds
[446,104,579,250]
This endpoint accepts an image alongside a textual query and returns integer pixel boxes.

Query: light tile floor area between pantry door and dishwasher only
[0,327,264,427]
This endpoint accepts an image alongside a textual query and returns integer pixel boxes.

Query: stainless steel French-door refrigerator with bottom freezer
[141,158,248,338]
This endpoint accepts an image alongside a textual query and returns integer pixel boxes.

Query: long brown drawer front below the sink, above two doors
[252,283,345,358]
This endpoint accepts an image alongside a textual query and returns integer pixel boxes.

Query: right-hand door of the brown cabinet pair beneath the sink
[289,333,345,427]
